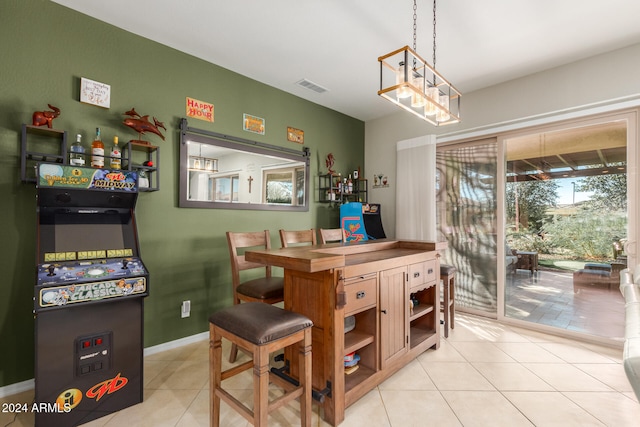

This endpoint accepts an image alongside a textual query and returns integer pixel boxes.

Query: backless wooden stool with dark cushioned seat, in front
[209,302,313,427]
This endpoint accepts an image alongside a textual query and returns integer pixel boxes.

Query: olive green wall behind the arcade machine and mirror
[0,0,364,386]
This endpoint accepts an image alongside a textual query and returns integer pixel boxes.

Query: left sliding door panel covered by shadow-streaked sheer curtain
[436,140,499,317]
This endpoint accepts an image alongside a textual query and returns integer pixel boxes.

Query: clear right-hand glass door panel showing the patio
[503,117,635,340]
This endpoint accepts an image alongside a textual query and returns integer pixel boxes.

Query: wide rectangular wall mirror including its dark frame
[180,119,310,211]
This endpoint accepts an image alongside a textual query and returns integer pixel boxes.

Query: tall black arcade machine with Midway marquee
[34,164,149,427]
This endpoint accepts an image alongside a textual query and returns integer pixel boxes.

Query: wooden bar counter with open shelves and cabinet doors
[245,239,446,426]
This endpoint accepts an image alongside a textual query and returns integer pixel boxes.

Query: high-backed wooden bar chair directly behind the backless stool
[227,230,284,363]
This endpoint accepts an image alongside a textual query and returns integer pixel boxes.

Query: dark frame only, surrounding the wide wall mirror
[178,118,311,212]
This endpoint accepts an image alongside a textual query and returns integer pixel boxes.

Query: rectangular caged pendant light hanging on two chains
[378,0,462,126]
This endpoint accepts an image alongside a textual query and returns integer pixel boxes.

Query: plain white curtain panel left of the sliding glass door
[396,135,436,242]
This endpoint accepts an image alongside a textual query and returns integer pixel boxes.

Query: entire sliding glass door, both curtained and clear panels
[436,111,640,341]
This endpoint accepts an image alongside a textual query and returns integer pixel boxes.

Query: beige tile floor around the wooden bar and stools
[5,314,640,427]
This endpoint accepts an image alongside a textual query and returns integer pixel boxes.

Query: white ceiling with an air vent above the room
[53,0,640,121]
